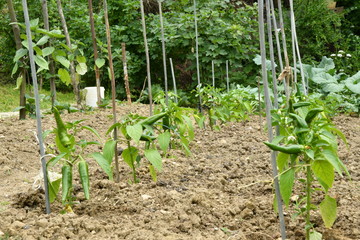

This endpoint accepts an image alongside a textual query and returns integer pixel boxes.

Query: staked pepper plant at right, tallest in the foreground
[264,95,349,239]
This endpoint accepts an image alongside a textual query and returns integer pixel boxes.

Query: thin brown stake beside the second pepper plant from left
[104,0,120,182]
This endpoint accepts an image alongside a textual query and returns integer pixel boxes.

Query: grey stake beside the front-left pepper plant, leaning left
[22,0,50,214]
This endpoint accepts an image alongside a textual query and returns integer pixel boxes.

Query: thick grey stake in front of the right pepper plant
[258,0,286,240]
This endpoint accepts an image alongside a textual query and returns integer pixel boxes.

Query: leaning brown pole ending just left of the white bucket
[56,0,81,107]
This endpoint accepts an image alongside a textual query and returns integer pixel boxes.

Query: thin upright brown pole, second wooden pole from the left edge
[41,0,56,107]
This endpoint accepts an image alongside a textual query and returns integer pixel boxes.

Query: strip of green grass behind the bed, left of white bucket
[0,84,75,112]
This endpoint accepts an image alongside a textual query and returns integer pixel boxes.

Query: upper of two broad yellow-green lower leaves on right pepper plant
[311,160,335,192]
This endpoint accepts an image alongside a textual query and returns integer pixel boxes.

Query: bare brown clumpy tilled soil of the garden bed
[0,104,360,240]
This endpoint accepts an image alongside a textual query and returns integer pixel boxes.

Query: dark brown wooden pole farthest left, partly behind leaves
[7,0,27,119]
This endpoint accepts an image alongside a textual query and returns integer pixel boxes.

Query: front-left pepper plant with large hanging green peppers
[44,108,100,212]
